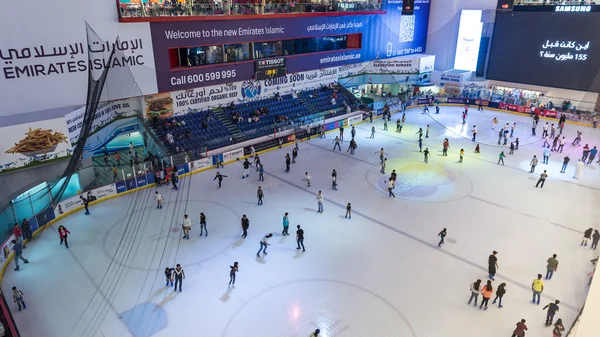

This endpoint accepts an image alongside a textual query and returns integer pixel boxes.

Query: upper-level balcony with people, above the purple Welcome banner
[116,0,385,22]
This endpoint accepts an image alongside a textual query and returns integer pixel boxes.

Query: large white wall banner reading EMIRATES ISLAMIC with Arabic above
[0,0,157,118]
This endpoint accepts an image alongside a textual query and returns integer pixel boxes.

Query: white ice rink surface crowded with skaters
[2,107,600,337]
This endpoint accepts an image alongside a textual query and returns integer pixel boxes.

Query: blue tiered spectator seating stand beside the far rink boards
[148,87,360,154]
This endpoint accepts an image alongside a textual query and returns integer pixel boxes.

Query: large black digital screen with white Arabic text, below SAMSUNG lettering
[487,12,600,92]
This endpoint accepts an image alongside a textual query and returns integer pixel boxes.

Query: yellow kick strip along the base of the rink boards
[0,103,592,284]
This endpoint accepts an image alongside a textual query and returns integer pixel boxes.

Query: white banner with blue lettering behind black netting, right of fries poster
[65,97,142,144]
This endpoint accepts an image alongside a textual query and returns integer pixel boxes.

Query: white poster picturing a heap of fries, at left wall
[0,118,72,171]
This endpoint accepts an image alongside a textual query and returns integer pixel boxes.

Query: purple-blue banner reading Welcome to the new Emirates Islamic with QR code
[150,0,430,92]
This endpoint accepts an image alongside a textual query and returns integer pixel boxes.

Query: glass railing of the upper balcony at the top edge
[119,0,381,18]
